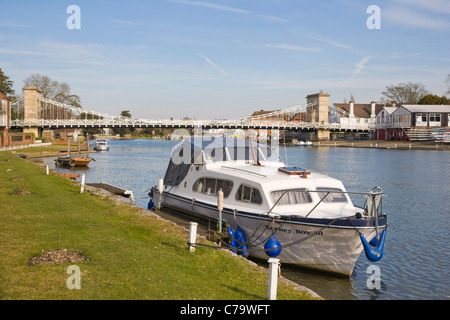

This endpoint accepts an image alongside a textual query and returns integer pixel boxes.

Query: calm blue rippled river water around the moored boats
[45,139,450,300]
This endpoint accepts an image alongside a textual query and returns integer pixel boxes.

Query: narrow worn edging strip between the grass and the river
[1,152,325,300]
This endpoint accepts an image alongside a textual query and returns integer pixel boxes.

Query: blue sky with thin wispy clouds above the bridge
[0,0,450,119]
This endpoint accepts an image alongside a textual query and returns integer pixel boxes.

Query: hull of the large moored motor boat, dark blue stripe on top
[153,192,387,276]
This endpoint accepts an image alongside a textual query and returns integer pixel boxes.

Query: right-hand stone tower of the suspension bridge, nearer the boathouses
[306,92,330,140]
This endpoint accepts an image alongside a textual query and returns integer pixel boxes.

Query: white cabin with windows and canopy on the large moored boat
[164,138,355,217]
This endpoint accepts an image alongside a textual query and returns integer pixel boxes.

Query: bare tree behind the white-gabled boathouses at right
[382,82,429,104]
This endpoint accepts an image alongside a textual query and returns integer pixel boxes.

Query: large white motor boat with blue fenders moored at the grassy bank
[149,138,387,275]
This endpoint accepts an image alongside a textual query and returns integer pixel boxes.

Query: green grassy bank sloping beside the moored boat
[0,152,318,300]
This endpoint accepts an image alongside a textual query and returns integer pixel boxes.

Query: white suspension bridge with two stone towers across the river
[10,87,374,136]
